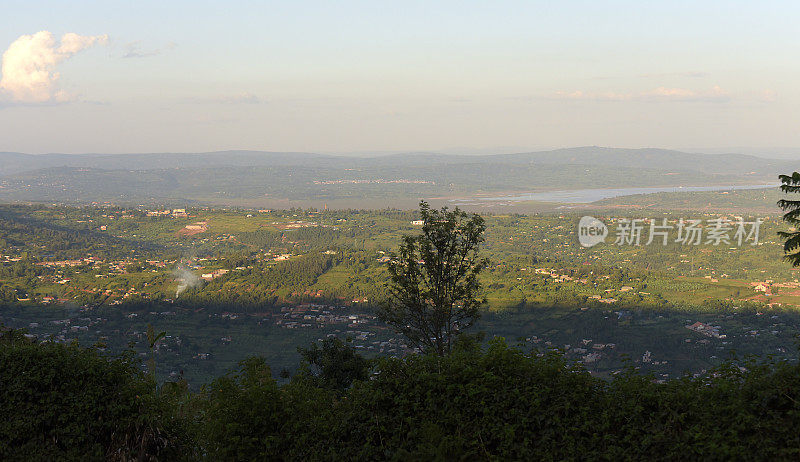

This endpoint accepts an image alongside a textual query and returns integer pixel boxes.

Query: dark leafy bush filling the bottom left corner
[0,331,185,460]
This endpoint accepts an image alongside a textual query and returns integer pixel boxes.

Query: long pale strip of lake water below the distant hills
[452,184,778,204]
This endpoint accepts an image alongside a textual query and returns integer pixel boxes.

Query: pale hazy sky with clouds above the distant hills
[0,0,800,153]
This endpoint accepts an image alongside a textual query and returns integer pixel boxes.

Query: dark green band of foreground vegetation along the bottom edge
[0,331,800,460]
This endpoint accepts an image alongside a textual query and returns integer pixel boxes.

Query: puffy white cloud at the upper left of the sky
[0,31,108,103]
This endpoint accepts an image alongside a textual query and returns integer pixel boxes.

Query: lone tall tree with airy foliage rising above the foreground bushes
[379,201,488,355]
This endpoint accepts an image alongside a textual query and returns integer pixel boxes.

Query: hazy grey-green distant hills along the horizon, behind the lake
[0,146,798,206]
